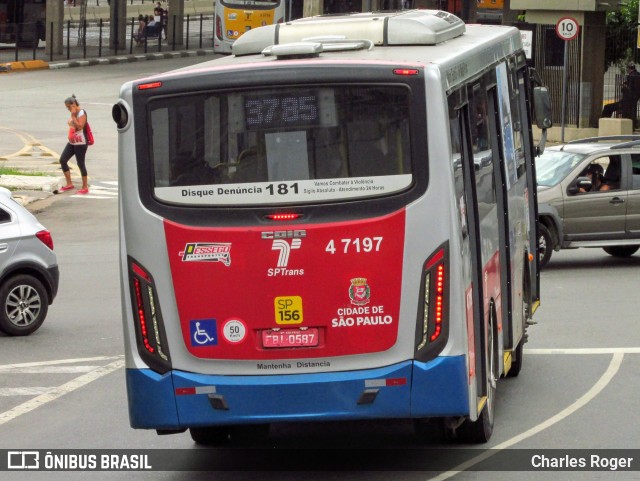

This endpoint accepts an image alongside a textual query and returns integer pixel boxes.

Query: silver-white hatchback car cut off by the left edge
[0,187,60,336]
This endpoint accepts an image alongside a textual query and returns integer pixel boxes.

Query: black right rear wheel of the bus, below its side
[456,309,498,443]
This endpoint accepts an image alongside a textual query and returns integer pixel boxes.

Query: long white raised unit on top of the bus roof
[232,10,465,55]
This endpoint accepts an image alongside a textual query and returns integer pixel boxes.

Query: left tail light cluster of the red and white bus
[129,258,171,373]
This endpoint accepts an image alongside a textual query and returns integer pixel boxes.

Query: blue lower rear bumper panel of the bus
[127,356,469,429]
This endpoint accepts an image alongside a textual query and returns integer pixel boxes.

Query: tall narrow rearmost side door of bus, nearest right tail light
[460,79,505,417]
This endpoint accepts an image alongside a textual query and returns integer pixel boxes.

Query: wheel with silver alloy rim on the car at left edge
[0,274,49,336]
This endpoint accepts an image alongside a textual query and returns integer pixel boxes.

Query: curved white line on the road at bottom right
[429,352,624,481]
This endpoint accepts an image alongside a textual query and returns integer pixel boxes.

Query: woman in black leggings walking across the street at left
[60,95,89,194]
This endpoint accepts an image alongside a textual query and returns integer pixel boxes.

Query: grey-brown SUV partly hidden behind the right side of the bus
[536,136,640,266]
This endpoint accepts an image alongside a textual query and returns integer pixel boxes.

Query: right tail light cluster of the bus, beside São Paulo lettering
[416,244,449,360]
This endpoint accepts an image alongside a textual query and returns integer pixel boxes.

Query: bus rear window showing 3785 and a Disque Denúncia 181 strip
[149,85,413,205]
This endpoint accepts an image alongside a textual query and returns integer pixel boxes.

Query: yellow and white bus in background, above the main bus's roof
[213,0,286,53]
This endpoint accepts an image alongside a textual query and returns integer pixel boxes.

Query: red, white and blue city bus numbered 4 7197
[113,10,550,443]
